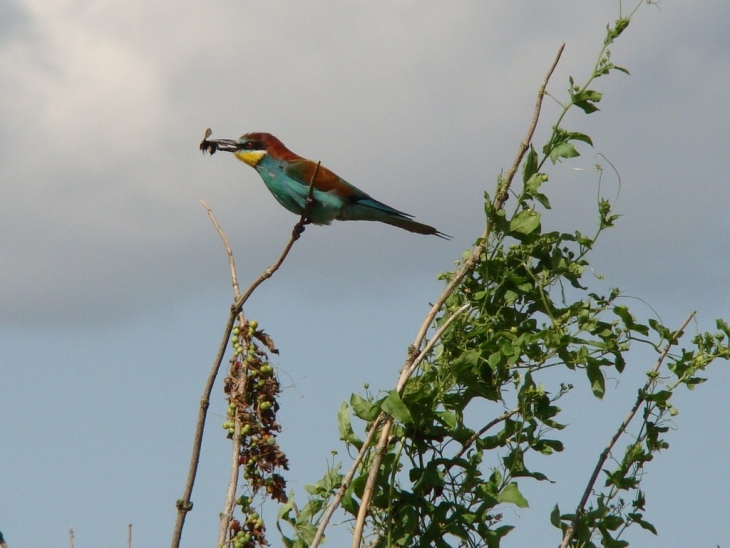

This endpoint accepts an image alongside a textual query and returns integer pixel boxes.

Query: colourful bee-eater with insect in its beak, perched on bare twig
[200,129,451,240]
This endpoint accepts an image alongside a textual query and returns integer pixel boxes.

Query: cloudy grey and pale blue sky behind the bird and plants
[0,0,730,548]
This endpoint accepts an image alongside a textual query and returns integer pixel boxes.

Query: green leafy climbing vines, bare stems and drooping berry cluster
[173,5,730,548]
